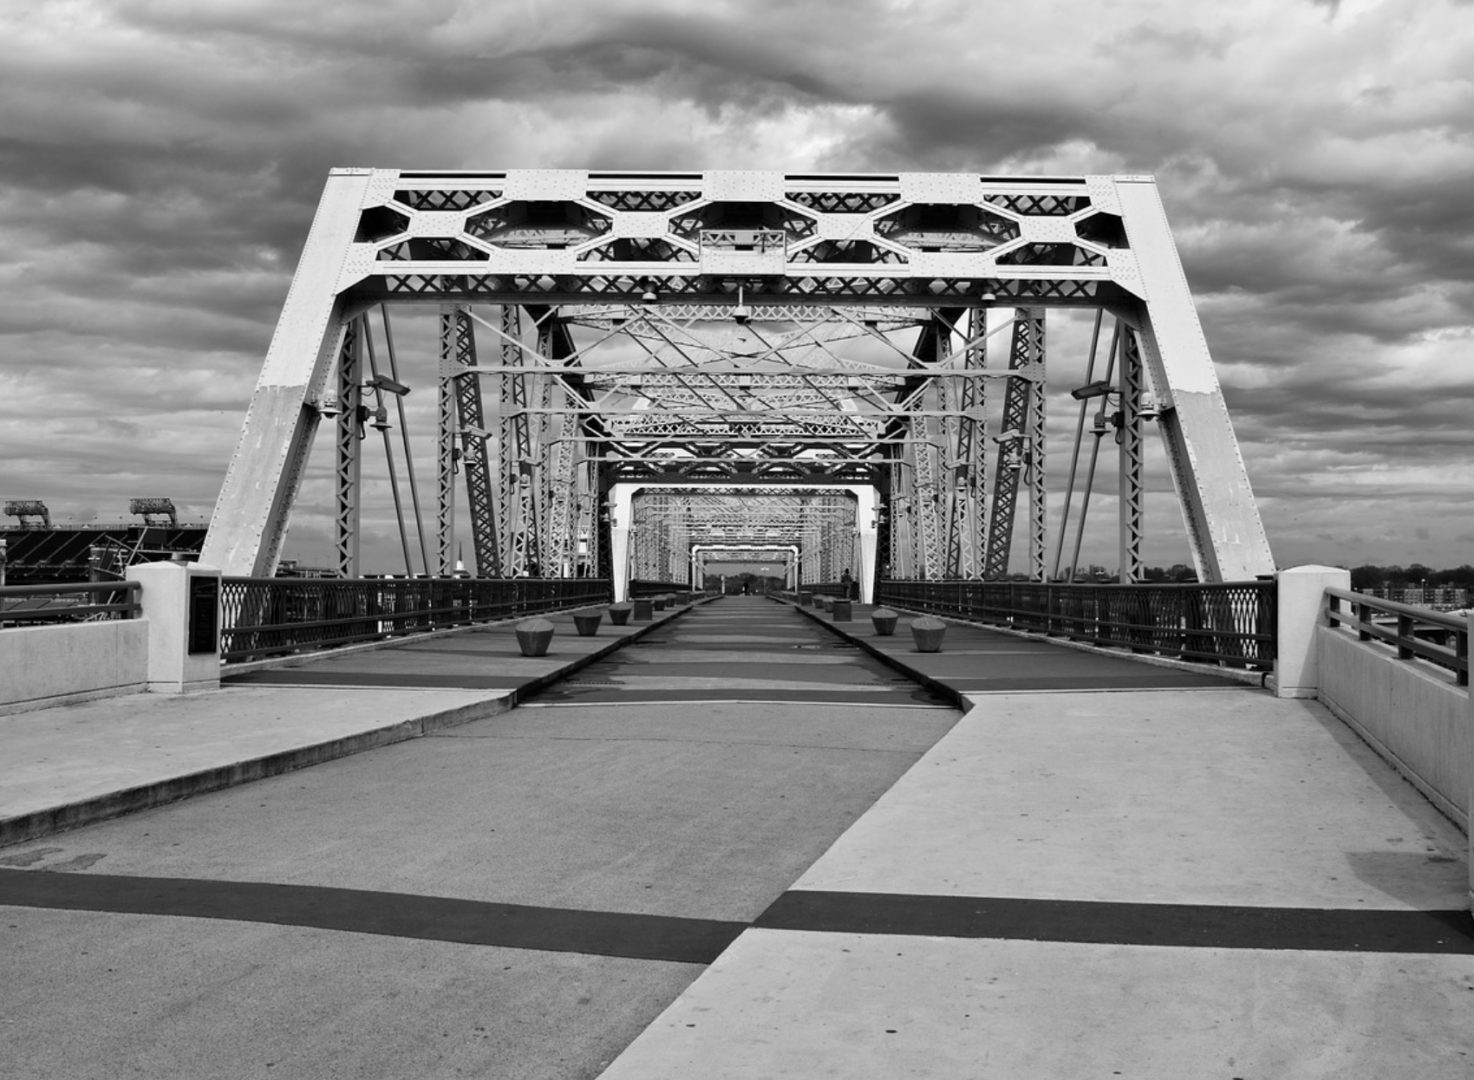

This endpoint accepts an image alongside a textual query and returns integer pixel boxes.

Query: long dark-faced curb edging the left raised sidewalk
[0,597,715,847]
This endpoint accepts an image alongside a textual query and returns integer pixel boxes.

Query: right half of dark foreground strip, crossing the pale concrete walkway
[753,890,1474,955]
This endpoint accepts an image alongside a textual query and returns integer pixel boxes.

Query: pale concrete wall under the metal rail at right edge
[1315,625,1474,832]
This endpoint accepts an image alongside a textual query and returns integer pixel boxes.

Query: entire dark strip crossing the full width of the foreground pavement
[0,869,1474,964]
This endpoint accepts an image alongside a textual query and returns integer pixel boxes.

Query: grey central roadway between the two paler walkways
[0,598,958,1077]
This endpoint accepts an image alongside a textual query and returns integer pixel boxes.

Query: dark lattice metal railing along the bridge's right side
[876,579,1276,670]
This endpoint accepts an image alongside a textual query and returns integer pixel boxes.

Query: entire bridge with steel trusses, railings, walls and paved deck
[0,169,1474,1079]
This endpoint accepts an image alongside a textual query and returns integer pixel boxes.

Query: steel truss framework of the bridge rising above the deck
[200,169,1274,598]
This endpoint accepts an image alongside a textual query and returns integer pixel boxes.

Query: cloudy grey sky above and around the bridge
[0,0,1474,569]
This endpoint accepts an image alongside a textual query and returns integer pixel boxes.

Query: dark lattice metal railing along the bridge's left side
[220,578,612,663]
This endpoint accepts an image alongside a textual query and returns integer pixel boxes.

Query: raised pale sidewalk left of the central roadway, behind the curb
[0,607,701,846]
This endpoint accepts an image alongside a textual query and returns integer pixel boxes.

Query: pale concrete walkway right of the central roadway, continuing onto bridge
[604,598,1474,1080]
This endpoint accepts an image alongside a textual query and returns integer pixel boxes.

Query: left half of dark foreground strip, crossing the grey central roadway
[0,869,747,964]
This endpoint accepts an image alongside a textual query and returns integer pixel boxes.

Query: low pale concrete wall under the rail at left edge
[0,619,149,713]
